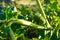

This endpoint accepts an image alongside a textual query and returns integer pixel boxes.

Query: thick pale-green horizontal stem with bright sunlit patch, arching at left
[8,19,51,29]
